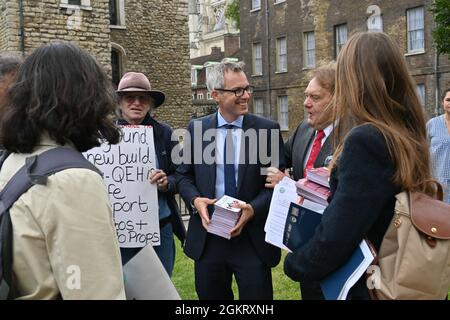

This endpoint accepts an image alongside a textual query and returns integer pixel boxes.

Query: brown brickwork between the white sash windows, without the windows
[240,0,450,136]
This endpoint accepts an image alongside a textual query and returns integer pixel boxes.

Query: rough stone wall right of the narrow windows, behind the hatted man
[111,0,193,128]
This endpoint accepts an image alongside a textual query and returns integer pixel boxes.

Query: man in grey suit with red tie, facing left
[266,64,336,300]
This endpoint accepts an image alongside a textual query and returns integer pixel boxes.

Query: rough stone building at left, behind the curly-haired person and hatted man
[0,0,193,128]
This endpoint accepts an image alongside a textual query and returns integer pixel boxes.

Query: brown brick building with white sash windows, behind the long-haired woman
[240,0,450,136]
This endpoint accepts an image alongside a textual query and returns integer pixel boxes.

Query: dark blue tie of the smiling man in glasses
[223,124,237,198]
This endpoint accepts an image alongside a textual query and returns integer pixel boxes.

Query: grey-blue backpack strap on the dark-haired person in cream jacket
[0,147,102,300]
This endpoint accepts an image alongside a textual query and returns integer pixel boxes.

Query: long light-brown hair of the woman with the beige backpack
[330,32,436,195]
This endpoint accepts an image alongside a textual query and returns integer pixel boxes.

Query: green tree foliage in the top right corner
[430,0,450,54]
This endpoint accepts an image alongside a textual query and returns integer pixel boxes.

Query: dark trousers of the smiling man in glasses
[195,232,273,300]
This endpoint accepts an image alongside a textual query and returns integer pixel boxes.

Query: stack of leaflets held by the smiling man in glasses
[208,195,245,239]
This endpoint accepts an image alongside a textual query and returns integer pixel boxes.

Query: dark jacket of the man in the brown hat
[118,114,186,244]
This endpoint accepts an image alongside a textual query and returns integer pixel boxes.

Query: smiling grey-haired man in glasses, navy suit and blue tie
[177,61,284,299]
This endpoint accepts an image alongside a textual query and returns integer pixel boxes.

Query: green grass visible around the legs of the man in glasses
[172,239,300,300]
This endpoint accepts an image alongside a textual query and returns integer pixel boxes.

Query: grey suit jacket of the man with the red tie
[284,121,333,180]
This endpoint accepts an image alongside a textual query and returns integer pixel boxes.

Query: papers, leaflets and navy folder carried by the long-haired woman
[264,168,374,300]
